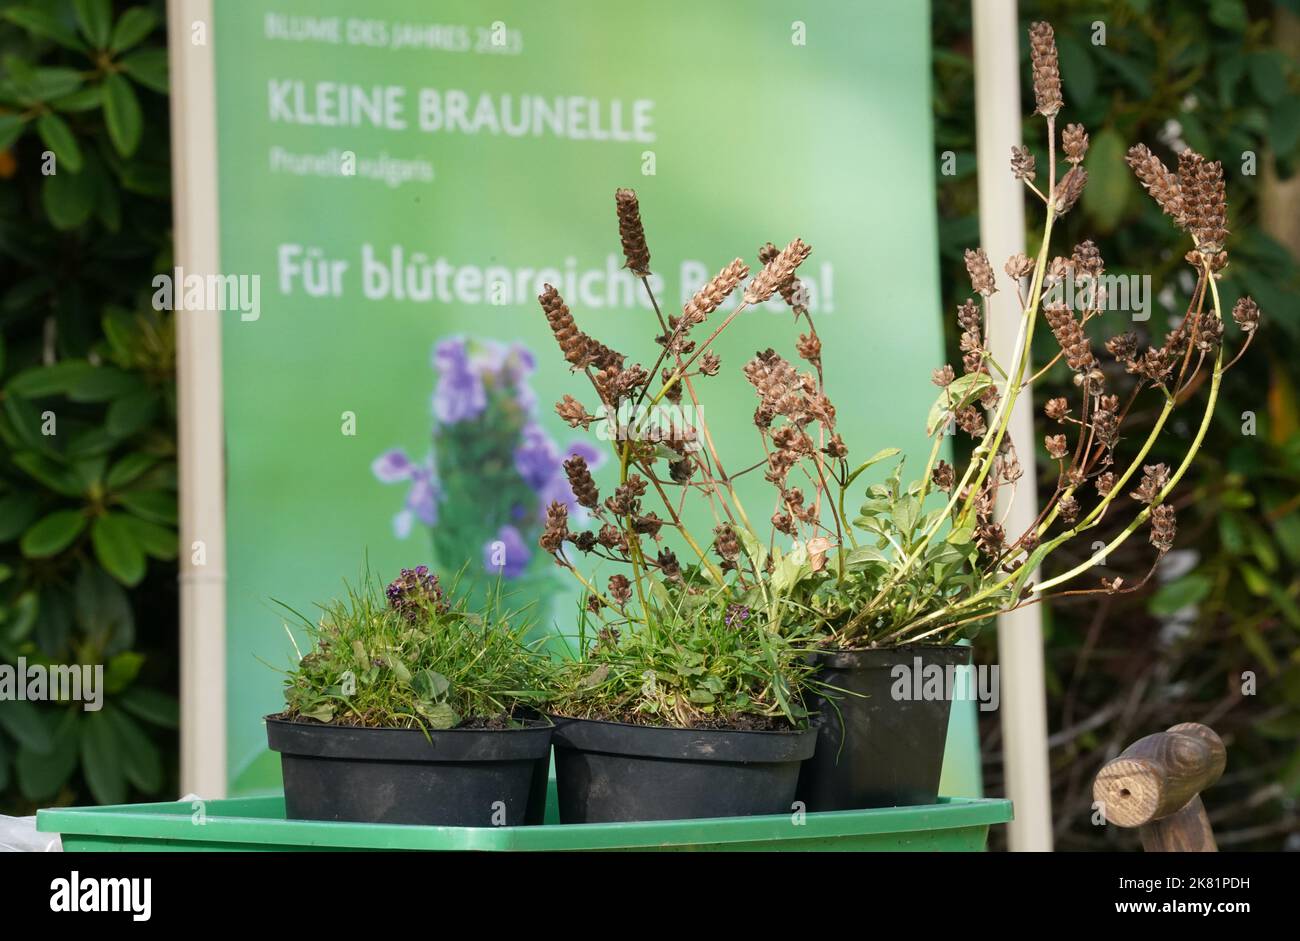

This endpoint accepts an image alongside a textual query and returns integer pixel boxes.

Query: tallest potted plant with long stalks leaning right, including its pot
[790,23,1258,810]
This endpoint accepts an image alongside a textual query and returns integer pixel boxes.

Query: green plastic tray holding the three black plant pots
[36,781,1011,853]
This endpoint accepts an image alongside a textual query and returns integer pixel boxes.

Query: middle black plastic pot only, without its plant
[555,716,816,824]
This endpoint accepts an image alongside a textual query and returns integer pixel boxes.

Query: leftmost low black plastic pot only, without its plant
[267,716,553,827]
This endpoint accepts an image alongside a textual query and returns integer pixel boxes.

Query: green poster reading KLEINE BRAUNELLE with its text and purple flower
[213,0,978,794]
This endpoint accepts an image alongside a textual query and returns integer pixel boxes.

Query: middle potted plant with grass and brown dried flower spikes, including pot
[540,190,815,823]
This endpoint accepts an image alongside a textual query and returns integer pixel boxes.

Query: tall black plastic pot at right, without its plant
[798,645,971,811]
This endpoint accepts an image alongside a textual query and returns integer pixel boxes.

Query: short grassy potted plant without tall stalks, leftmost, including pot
[267,565,551,827]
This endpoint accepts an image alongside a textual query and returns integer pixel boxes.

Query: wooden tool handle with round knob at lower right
[1092,723,1227,853]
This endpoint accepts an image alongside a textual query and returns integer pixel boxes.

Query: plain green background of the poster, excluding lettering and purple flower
[215,0,979,794]
